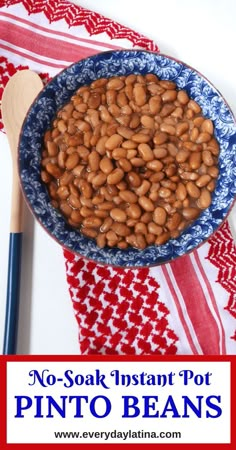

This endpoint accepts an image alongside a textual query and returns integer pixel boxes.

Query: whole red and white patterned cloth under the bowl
[0,0,236,355]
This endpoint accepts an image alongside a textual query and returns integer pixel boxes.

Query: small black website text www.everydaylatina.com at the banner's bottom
[54,430,182,441]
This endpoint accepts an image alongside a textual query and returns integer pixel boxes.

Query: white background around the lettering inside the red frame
[7,361,230,443]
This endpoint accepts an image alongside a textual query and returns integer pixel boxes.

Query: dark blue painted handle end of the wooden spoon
[3,233,23,355]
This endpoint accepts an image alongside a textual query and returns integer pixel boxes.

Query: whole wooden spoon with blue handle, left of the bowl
[1,70,43,355]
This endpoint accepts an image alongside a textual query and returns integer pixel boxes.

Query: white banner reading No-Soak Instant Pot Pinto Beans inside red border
[7,360,231,444]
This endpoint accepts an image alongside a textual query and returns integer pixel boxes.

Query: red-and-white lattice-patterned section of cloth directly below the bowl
[64,250,178,355]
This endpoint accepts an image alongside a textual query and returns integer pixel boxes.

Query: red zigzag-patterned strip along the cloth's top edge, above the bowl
[0,0,159,52]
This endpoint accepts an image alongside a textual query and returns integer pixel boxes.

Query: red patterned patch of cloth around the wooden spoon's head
[0,56,49,130]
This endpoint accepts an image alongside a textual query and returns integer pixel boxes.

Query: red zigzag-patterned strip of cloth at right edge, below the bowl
[207,222,236,324]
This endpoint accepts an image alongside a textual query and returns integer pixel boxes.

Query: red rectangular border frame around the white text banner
[0,355,236,450]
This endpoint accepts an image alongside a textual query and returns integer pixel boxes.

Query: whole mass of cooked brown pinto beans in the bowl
[41,74,219,250]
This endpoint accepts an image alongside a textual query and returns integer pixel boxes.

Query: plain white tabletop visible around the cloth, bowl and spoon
[0,0,236,354]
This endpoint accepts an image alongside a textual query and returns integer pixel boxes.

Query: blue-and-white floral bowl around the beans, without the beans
[19,50,236,267]
